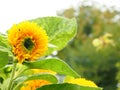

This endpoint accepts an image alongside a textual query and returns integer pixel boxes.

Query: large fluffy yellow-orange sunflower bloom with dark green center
[8,21,48,63]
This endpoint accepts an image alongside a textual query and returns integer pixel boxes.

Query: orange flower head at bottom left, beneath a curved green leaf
[20,80,50,90]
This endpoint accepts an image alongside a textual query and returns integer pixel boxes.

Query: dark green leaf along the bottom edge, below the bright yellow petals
[36,83,102,90]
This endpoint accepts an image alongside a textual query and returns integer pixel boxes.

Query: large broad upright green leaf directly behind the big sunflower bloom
[31,17,77,54]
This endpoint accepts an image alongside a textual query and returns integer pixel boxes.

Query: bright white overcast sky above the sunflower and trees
[0,0,120,33]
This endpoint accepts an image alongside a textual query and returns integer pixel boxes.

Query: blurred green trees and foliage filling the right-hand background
[57,0,120,90]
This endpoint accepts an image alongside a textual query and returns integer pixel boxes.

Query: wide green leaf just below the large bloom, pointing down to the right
[24,58,80,77]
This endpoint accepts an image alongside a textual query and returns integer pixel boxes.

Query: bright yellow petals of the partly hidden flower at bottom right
[65,77,98,87]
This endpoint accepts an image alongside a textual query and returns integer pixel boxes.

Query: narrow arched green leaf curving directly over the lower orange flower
[13,74,58,90]
